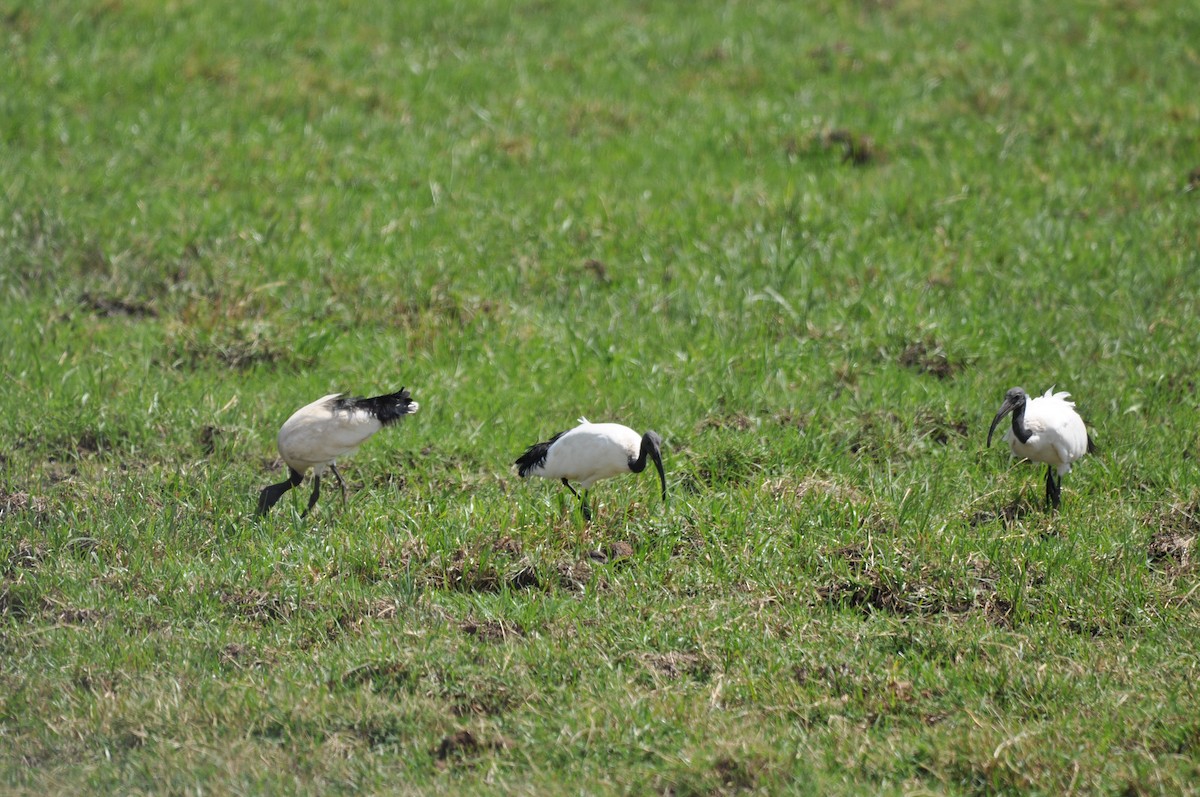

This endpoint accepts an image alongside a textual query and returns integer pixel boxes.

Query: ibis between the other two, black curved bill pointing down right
[515,418,667,520]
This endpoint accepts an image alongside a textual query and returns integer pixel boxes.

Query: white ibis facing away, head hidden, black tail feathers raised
[258,388,419,516]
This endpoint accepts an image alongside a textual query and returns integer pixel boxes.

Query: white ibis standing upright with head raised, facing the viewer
[988,388,1096,509]
